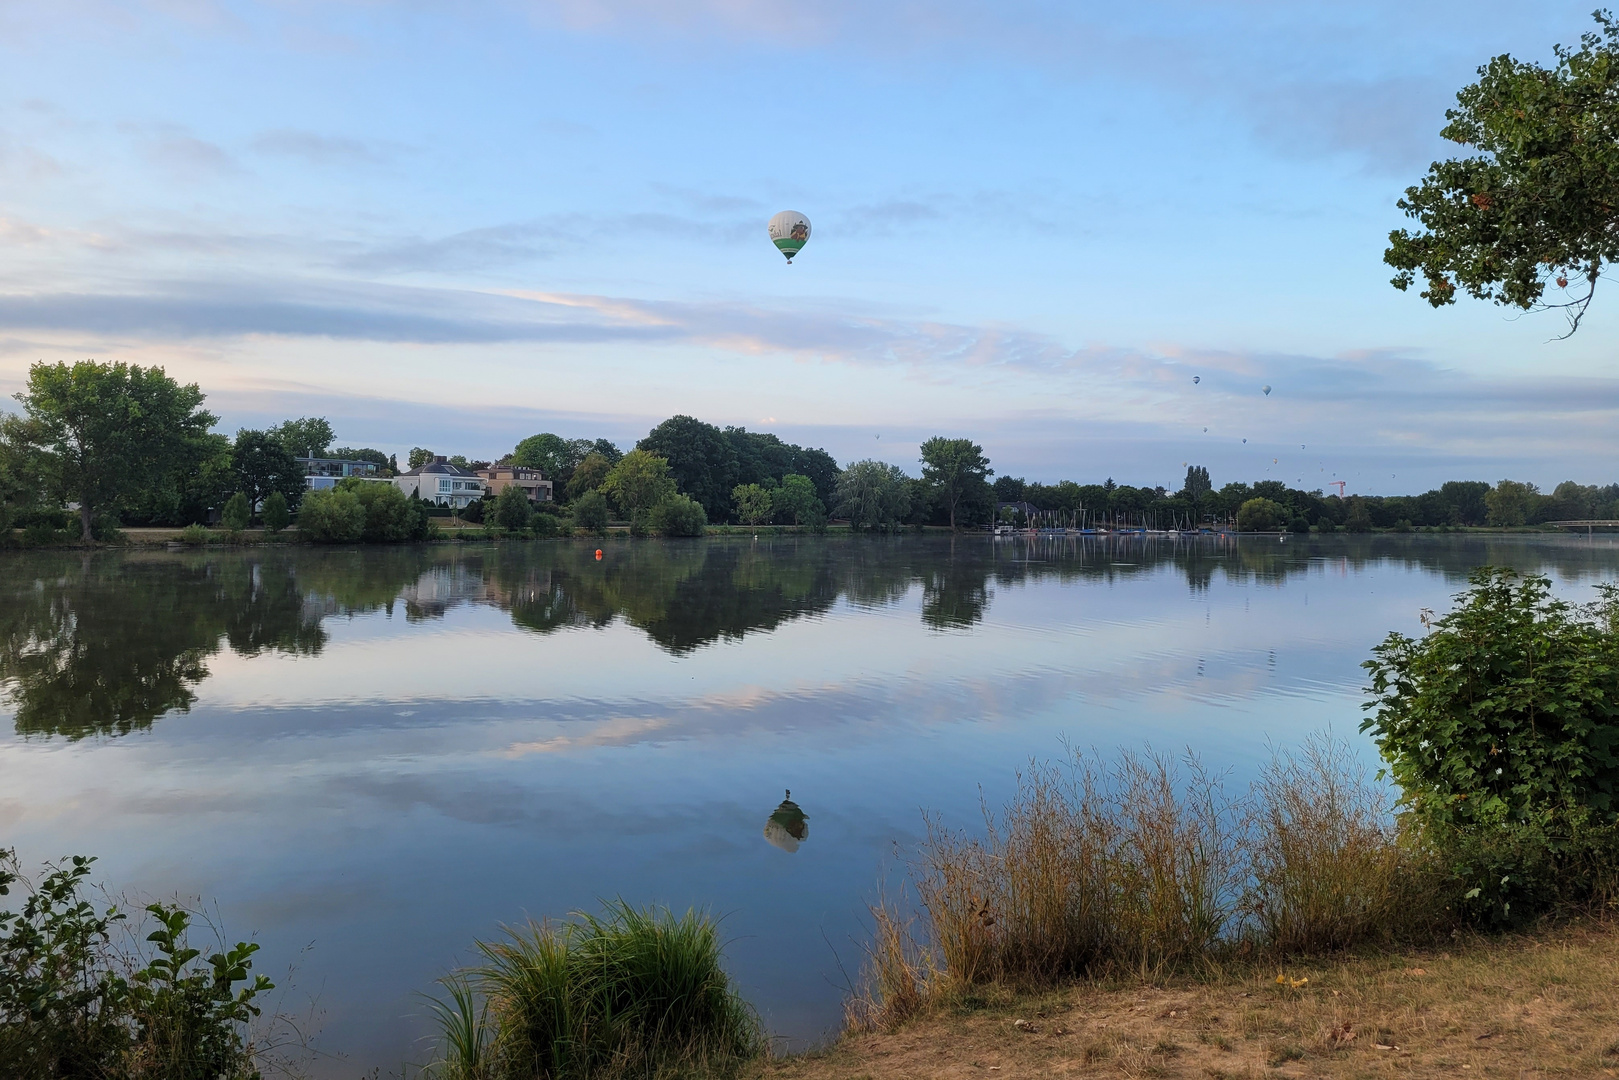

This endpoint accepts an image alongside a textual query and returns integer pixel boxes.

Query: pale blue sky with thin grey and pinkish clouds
[0,0,1619,494]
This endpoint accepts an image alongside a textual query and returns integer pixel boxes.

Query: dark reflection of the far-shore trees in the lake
[0,534,1611,738]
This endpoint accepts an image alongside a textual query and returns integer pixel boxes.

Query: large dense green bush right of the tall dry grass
[1363,567,1619,921]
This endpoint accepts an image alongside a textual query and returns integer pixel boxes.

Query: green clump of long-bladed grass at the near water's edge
[436,902,764,1080]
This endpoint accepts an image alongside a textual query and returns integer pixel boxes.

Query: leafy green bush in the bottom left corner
[0,850,274,1080]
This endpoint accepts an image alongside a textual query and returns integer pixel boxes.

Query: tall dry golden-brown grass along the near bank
[852,737,1443,1027]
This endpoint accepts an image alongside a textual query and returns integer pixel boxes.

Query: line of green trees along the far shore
[0,361,1599,546]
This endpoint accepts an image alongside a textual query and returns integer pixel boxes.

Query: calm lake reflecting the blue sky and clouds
[0,534,1619,1080]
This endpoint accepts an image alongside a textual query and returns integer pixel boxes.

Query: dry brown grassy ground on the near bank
[759,923,1619,1080]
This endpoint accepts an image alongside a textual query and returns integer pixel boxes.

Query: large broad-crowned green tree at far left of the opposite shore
[8,359,215,539]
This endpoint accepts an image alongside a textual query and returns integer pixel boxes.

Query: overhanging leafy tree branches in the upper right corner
[1383,11,1619,337]
